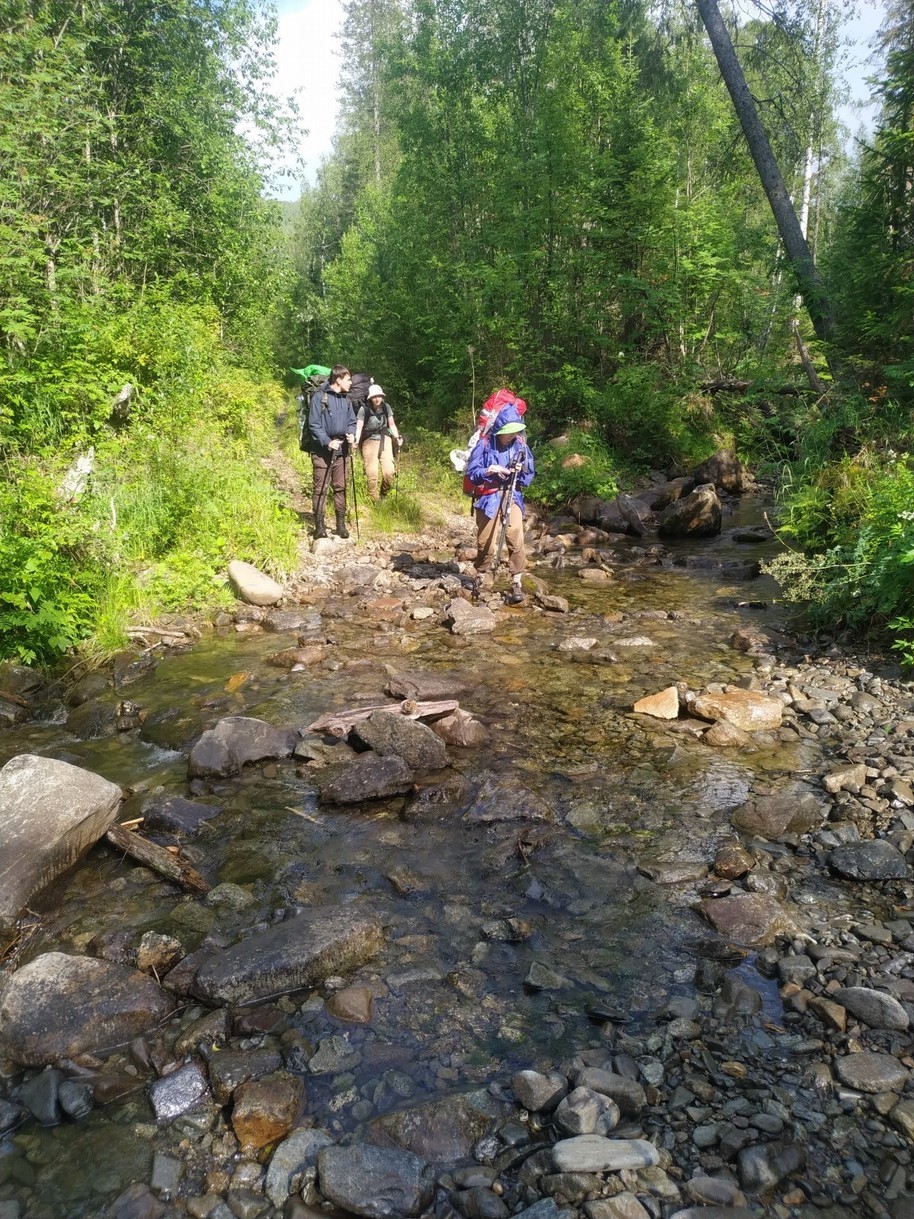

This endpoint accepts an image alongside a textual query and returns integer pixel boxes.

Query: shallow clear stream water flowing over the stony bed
[0,501,853,1217]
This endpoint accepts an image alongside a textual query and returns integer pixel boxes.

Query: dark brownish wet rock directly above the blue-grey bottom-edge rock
[368,1092,495,1163]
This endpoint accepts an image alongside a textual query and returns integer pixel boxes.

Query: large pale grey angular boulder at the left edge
[0,753,122,925]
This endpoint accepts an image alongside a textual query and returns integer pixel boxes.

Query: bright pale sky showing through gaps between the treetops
[268,0,884,199]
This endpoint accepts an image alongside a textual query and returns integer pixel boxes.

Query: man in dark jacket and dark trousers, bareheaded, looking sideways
[308,364,356,538]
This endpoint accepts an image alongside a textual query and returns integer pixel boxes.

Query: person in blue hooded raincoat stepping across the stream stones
[467,403,534,605]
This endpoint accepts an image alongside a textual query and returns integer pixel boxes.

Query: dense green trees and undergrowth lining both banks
[0,0,914,662]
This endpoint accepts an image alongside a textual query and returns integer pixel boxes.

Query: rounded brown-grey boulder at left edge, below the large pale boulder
[0,952,174,1067]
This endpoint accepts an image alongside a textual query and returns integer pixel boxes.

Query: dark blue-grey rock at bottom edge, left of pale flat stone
[317,1145,434,1219]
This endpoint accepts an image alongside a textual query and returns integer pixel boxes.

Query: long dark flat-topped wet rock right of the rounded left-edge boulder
[194,907,384,1004]
